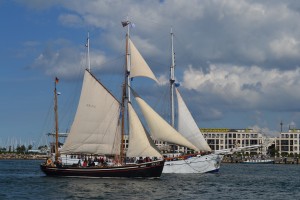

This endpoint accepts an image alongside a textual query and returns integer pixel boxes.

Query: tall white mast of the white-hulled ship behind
[170,28,175,127]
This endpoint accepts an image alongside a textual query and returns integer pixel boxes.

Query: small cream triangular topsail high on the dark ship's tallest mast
[129,39,158,83]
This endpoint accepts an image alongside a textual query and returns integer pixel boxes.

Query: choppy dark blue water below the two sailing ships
[0,160,300,200]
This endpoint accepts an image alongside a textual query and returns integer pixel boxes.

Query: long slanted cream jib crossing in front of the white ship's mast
[133,93,199,151]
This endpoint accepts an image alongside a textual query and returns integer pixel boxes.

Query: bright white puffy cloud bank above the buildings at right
[183,64,300,110]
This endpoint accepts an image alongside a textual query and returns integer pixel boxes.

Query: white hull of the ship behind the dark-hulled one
[162,154,223,174]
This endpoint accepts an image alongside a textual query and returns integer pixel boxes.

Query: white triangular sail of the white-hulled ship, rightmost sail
[175,88,211,151]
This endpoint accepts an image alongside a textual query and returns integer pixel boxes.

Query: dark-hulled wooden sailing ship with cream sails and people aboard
[40,21,165,178]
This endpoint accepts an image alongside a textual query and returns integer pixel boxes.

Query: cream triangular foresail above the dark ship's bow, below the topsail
[126,103,162,157]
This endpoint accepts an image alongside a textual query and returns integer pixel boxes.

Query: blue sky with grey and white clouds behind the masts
[0,0,300,146]
